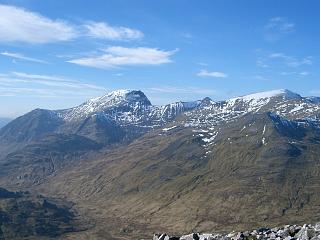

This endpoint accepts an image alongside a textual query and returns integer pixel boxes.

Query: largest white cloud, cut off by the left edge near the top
[0,4,78,43]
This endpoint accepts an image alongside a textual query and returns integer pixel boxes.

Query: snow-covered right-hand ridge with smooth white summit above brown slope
[181,89,320,126]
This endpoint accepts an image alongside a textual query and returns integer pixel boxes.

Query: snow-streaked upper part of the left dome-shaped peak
[56,90,201,128]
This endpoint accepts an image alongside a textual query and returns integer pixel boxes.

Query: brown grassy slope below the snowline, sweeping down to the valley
[30,114,320,237]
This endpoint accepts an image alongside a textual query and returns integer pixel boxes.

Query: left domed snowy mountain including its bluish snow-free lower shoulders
[0,90,201,154]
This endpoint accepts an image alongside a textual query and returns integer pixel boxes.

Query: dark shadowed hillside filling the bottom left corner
[0,188,84,240]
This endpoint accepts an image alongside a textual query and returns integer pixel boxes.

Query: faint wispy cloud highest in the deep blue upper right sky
[264,17,295,42]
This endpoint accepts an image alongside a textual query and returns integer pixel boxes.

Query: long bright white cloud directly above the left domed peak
[67,46,177,69]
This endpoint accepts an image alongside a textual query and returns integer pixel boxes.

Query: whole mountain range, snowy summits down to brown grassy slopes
[0,89,320,239]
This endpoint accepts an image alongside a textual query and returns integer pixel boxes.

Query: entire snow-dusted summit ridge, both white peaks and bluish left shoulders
[0,89,320,151]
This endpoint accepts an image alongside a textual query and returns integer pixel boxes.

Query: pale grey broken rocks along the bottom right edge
[153,223,320,240]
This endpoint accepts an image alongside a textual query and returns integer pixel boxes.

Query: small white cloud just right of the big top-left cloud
[84,22,143,40]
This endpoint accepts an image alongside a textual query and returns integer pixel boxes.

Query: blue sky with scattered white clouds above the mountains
[0,0,320,117]
